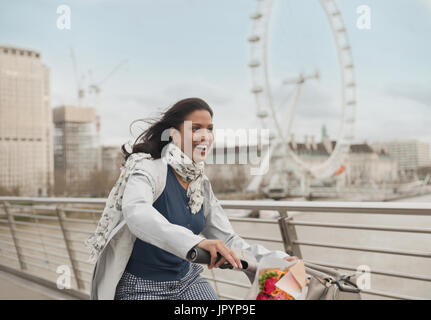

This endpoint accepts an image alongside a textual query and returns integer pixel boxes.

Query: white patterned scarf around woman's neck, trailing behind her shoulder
[85,142,204,263]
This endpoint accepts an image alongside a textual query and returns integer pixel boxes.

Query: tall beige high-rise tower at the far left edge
[0,46,54,196]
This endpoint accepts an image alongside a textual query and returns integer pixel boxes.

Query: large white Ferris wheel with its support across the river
[248,0,356,192]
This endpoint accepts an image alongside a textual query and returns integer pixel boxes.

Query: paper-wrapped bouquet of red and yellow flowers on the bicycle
[248,257,308,300]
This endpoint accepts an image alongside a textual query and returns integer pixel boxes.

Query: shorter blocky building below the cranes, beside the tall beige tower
[53,106,100,195]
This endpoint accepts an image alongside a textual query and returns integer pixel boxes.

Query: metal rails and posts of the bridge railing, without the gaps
[0,197,431,299]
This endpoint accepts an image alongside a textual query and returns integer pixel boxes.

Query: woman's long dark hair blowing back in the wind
[121,98,213,161]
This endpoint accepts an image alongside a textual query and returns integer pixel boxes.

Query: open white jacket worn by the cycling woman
[90,159,289,300]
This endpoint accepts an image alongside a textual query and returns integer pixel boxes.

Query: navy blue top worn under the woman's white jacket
[126,165,205,281]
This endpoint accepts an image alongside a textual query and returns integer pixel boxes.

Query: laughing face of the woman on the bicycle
[173,110,214,162]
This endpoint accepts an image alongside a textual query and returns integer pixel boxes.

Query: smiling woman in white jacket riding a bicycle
[86,98,289,300]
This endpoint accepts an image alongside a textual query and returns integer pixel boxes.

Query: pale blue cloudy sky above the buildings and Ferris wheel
[0,0,431,145]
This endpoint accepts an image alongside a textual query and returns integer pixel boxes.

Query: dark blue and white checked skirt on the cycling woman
[114,263,219,300]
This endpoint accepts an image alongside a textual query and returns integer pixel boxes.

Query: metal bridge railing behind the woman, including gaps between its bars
[0,197,431,299]
